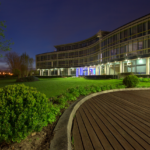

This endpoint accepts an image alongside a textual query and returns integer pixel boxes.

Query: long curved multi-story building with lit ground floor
[36,14,150,76]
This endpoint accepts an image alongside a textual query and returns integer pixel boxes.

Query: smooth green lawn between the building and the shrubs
[0,78,122,98]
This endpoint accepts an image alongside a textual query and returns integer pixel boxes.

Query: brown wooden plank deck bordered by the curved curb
[72,90,150,150]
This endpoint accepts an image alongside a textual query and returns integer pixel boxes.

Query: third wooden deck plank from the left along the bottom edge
[79,108,104,150]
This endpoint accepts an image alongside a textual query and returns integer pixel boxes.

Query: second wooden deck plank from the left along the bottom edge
[76,111,94,150]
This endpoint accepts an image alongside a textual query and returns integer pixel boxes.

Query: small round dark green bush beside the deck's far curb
[123,75,139,88]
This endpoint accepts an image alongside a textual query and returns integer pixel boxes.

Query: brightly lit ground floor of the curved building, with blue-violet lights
[37,57,150,77]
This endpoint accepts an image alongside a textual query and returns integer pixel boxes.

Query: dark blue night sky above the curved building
[0,0,150,69]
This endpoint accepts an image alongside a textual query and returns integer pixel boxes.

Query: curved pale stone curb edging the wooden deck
[50,88,150,150]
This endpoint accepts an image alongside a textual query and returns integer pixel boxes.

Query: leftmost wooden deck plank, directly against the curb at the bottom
[73,117,84,150]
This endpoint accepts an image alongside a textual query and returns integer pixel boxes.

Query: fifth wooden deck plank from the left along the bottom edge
[84,103,123,150]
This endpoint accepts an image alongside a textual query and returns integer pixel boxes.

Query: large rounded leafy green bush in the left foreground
[0,84,60,143]
